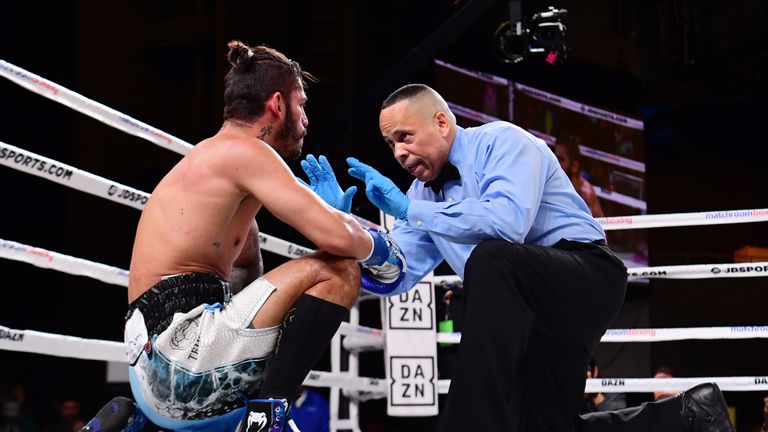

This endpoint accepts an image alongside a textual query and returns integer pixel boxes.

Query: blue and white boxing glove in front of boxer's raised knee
[360,228,408,295]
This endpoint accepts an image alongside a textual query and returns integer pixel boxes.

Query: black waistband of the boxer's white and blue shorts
[125,273,232,337]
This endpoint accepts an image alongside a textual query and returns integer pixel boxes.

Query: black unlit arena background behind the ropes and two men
[0,0,768,430]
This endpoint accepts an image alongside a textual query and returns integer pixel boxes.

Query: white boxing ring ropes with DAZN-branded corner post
[0,60,768,431]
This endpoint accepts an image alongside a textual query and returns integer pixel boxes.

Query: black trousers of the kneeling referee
[438,240,627,432]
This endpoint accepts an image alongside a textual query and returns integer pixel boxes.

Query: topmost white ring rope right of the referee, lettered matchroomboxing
[595,208,768,231]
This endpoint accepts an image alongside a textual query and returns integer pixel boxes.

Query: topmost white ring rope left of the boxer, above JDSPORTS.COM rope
[0,60,192,155]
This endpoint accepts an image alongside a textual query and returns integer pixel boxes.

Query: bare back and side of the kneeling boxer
[128,126,270,301]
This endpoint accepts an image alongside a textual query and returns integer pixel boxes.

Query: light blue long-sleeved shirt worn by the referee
[392,122,605,292]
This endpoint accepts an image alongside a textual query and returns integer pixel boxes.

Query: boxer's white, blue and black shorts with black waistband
[126,273,280,431]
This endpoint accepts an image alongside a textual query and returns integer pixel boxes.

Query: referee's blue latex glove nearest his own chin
[347,158,411,219]
